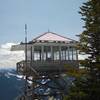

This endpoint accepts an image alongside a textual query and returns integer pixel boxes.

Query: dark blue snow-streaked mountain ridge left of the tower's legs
[0,69,24,100]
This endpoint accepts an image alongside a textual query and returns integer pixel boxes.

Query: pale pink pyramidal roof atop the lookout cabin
[33,32,74,42]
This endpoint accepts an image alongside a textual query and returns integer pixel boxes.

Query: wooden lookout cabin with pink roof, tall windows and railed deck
[11,32,78,100]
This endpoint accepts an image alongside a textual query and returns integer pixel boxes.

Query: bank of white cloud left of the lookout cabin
[0,43,24,69]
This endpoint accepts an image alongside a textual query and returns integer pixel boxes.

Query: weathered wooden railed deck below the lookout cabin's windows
[17,60,78,74]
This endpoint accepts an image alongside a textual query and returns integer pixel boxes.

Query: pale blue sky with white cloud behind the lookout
[0,0,85,67]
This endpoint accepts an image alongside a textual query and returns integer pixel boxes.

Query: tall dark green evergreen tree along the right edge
[68,0,100,100]
